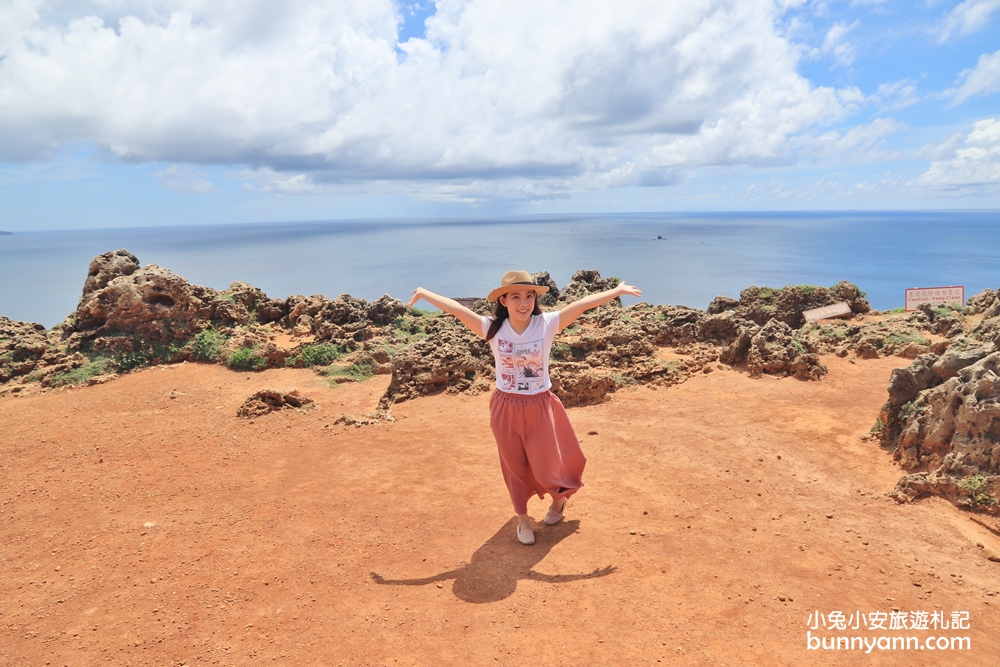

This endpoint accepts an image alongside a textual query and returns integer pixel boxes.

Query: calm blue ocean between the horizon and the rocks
[0,211,1000,327]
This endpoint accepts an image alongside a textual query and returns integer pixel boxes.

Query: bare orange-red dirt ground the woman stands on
[0,357,1000,667]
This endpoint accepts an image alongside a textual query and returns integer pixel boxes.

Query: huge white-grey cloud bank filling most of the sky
[0,0,857,198]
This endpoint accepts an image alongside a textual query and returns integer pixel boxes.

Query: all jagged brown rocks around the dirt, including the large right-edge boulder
[0,249,1000,513]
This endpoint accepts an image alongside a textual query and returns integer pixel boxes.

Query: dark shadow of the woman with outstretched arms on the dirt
[371,517,615,602]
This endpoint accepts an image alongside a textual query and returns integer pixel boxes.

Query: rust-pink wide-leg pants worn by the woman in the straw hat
[490,389,587,514]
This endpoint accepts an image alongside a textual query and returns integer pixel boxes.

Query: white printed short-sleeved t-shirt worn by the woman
[483,311,559,394]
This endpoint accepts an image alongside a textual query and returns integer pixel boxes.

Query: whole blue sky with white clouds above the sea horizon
[0,0,1000,231]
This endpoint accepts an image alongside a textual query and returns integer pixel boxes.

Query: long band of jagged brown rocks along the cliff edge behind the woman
[0,250,984,412]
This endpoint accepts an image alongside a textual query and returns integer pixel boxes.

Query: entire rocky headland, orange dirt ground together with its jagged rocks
[0,250,1000,667]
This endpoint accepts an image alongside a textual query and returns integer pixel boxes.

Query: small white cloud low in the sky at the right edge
[919,118,1000,194]
